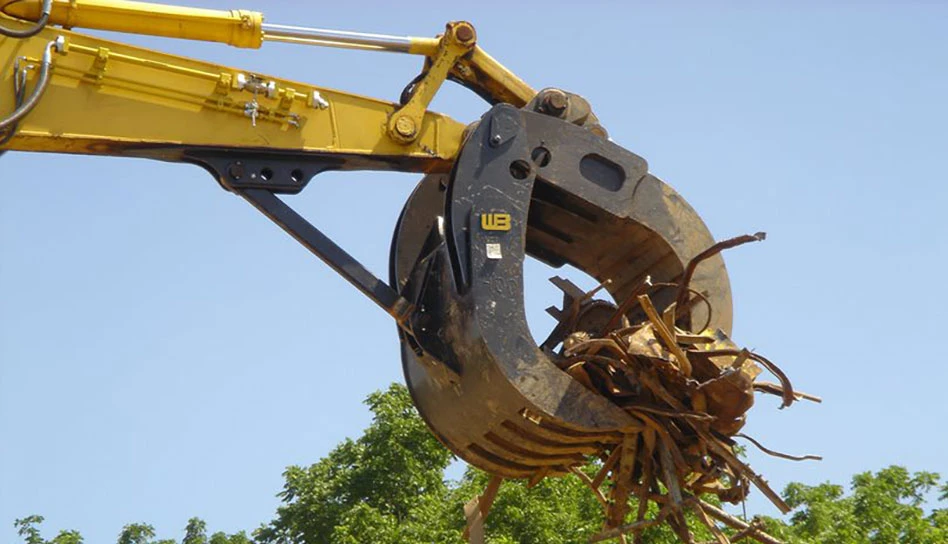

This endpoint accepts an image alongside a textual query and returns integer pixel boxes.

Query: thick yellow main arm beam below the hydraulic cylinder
[0,21,464,172]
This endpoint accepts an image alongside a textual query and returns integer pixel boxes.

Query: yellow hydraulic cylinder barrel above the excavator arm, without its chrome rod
[0,0,263,48]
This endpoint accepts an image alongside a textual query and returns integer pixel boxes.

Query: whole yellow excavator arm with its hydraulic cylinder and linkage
[0,0,535,172]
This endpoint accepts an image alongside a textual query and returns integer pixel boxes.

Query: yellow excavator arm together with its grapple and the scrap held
[0,0,811,543]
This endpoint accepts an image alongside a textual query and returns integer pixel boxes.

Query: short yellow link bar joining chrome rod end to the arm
[388,21,477,144]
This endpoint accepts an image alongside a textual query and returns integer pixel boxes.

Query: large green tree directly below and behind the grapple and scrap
[256,385,711,544]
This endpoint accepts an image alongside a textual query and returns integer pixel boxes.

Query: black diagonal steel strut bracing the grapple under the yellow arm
[234,189,414,328]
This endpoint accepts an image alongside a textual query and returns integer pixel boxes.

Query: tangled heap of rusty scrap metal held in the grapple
[462,233,820,544]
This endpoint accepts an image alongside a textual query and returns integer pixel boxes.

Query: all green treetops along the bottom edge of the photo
[14,385,948,544]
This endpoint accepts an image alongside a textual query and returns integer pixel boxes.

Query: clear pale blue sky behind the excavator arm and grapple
[0,0,948,543]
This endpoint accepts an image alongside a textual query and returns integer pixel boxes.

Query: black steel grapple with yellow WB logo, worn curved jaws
[391,104,731,478]
